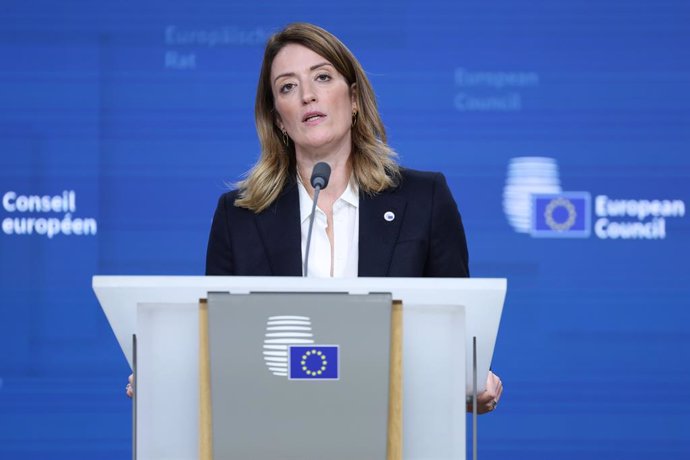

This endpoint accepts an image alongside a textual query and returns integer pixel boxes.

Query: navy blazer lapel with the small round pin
[358,192,407,276]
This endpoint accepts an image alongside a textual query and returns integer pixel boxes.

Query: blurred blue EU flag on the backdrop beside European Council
[530,192,592,238]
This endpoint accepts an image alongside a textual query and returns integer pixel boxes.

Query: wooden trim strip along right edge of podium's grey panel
[386,300,403,460]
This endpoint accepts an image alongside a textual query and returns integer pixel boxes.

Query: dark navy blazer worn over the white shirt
[206,169,469,277]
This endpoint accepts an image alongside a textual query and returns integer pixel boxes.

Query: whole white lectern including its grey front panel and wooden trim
[93,276,506,459]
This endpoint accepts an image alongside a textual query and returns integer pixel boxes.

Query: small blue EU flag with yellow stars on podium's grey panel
[288,345,340,380]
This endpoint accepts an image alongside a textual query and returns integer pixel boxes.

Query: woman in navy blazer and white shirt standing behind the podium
[133,23,502,413]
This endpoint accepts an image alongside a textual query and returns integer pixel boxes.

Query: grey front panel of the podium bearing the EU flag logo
[208,293,392,460]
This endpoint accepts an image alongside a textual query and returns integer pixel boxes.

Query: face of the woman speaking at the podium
[271,44,356,162]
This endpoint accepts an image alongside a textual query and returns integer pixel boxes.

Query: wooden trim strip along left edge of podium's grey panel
[199,299,213,460]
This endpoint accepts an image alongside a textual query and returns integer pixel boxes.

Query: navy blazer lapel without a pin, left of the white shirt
[256,182,302,276]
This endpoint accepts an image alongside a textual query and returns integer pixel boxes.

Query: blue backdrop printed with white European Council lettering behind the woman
[0,0,690,460]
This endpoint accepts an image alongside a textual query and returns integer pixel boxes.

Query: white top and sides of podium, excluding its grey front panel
[93,276,507,460]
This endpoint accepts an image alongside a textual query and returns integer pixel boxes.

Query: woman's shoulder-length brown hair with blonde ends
[235,23,400,213]
